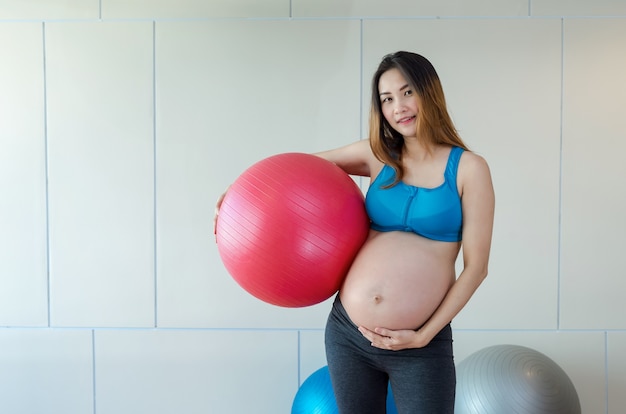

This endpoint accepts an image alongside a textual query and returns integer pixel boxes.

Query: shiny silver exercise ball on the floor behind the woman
[454,345,580,414]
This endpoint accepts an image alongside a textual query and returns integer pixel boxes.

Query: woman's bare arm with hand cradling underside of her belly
[362,152,495,350]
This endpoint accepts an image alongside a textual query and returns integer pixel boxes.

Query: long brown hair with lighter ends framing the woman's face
[369,51,468,186]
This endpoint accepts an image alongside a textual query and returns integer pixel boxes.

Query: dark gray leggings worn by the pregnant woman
[325,295,456,414]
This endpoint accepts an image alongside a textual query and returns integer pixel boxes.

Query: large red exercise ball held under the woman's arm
[216,153,369,308]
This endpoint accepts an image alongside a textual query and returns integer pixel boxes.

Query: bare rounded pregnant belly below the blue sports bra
[340,231,459,329]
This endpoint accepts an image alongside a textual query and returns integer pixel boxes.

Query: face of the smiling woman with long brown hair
[378,68,419,137]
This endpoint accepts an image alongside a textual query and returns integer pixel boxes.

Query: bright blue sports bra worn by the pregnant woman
[365,147,464,242]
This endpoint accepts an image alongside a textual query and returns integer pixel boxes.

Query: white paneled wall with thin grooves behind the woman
[0,0,626,414]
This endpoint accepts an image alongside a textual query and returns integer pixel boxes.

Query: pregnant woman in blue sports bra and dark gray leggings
[216,52,494,414]
